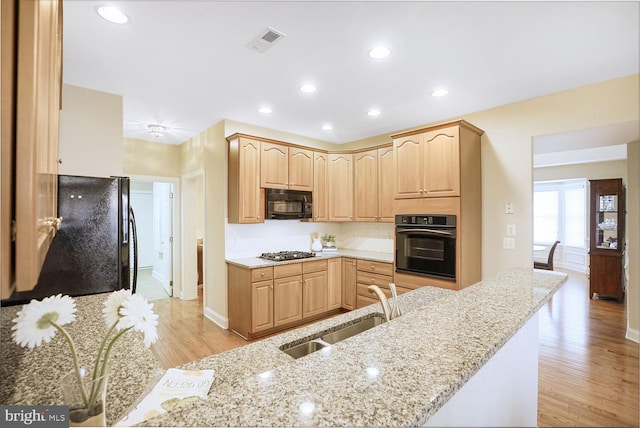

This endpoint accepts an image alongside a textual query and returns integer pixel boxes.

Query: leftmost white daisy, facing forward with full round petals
[11,294,76,349]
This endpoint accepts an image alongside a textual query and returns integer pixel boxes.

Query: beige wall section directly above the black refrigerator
[58,85,124,177]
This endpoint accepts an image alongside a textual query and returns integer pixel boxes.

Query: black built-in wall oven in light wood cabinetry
[396,214,456,281]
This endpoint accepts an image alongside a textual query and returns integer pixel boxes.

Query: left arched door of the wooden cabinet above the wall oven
[393,135,424,199]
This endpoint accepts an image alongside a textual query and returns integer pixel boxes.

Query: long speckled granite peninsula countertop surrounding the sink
[143,268,567,426]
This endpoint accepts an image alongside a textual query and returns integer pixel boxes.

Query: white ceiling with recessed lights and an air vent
[64,0,640,149]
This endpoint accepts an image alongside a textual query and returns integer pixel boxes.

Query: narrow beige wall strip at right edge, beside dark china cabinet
[627,141,640,342]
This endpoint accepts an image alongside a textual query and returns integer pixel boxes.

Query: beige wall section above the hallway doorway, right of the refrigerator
[123,138,182,177]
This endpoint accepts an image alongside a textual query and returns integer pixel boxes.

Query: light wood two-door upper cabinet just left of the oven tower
[353,145,394,222]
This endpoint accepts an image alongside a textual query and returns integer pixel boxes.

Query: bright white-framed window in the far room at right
[533,179,587,248]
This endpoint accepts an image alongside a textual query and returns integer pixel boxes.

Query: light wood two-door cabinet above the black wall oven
[393,121,482,199]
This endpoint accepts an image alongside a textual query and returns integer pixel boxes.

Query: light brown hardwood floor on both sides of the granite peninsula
[151,272,639,427]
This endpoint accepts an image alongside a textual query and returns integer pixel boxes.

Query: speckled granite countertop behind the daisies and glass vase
[0,293,164,425]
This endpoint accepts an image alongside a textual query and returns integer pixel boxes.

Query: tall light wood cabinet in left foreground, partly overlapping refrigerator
[0,0,62,298]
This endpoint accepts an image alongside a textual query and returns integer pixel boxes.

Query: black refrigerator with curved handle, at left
[2,175,137,306]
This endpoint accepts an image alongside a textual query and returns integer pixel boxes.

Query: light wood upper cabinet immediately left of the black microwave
[228,134,264,223]
